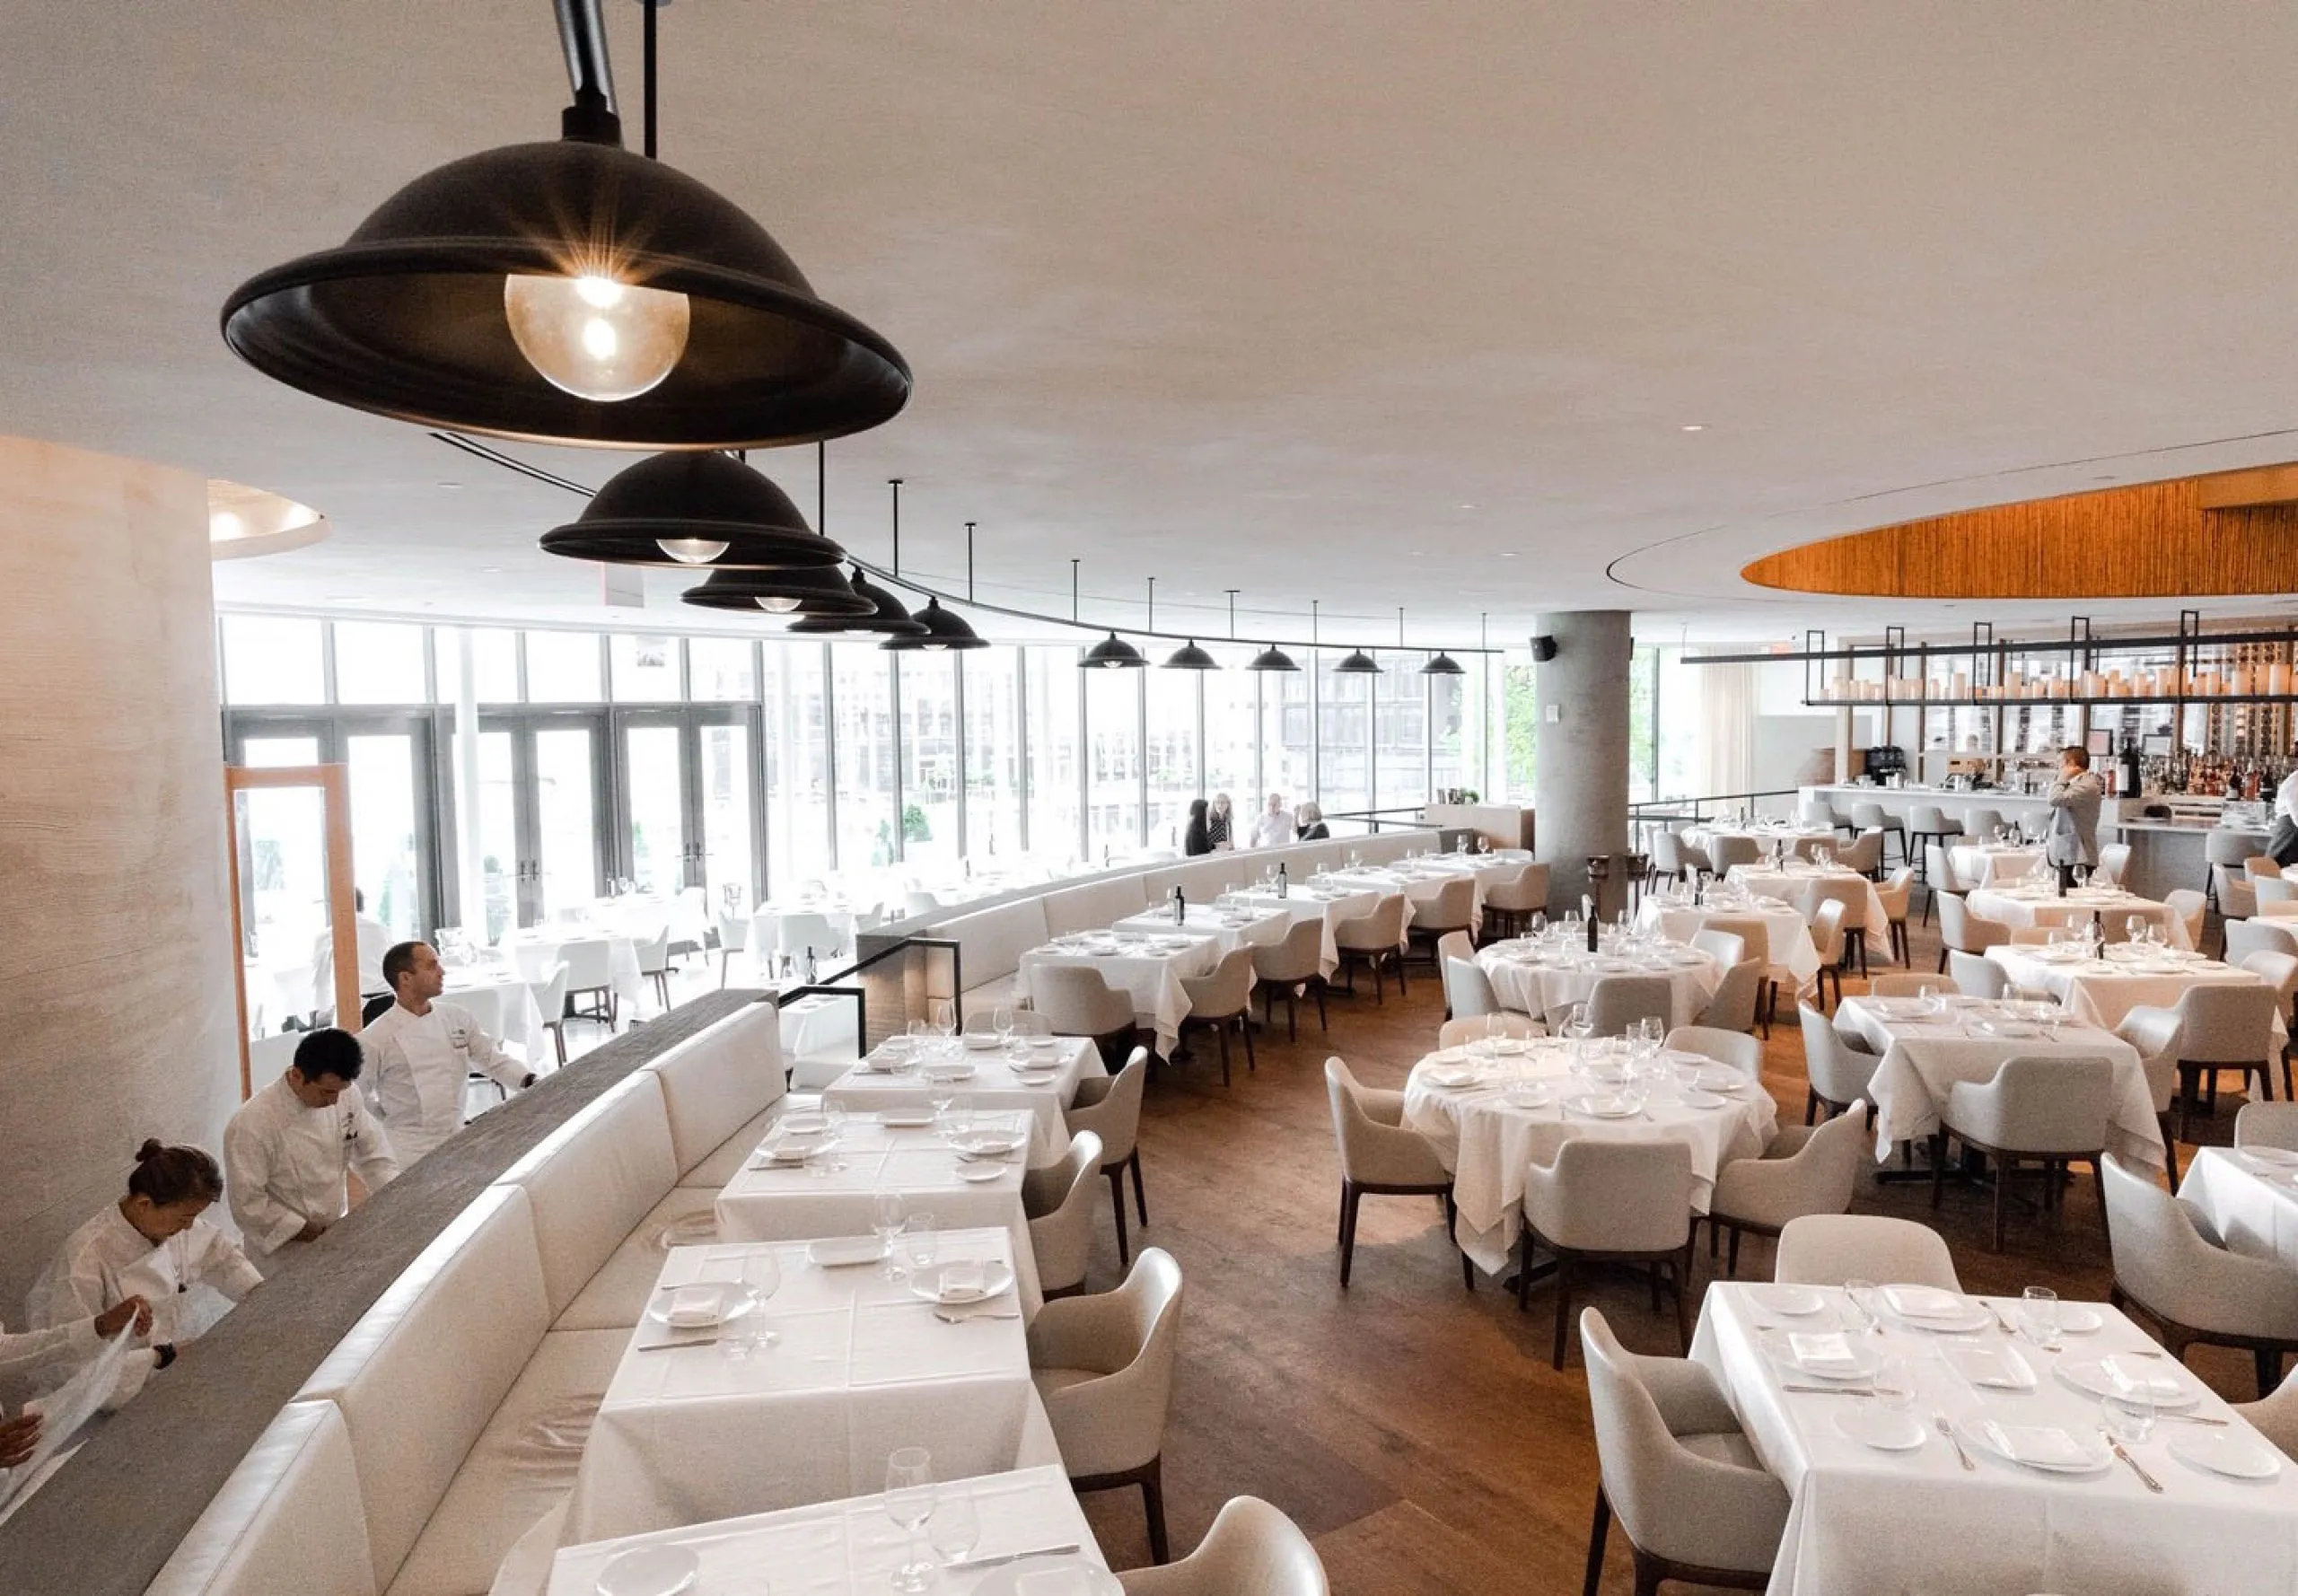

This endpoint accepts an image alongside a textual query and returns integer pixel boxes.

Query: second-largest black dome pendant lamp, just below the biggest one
[542,450,846,569]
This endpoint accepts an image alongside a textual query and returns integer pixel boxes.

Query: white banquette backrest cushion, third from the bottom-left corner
[496,1070,678,1318]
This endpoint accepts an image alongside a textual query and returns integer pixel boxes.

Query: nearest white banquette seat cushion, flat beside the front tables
[389,1329,629,1596]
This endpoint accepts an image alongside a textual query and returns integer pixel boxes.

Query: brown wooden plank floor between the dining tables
[1066,904,2254,1596]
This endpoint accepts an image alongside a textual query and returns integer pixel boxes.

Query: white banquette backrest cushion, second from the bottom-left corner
[296,1185,549,1589]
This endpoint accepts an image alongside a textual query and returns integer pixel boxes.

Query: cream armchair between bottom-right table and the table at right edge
[2098,1153,2298,1396]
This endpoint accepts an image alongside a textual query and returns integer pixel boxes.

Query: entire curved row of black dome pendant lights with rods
[223,0,1488,675]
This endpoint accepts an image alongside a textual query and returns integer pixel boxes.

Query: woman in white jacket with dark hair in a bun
[30,1141,264,1406]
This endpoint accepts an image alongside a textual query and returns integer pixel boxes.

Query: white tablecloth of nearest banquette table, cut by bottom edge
[549,1453,1108,1596]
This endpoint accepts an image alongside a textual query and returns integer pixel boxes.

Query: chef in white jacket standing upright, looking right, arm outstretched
[358,942,535,1169]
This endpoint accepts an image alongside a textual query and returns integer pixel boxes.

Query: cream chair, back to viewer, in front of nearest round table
[1517,1136,1691,1369]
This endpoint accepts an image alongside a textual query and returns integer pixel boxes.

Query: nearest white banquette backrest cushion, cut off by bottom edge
[145,1401,374,1596]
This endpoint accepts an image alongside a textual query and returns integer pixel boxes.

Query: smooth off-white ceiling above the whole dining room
[13,0,2298,643]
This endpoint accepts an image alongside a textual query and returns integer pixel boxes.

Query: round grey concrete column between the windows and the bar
[1533,609,1634,914]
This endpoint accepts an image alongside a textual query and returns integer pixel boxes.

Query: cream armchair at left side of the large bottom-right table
[1581,1309,1788,1596]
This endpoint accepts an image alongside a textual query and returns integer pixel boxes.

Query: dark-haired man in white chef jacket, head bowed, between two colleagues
[223,1027,399,1275]
